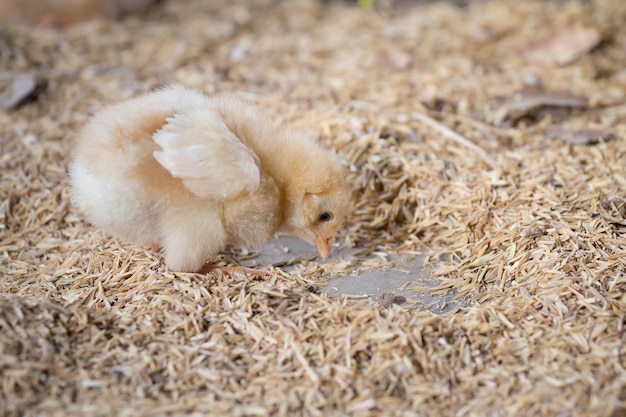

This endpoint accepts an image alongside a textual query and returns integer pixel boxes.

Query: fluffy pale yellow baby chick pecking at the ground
[69,85,348,272]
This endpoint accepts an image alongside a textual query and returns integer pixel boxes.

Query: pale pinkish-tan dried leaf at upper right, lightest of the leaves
[522,27,601,65]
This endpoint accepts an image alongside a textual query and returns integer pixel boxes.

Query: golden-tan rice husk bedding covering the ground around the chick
[0,0,626,417]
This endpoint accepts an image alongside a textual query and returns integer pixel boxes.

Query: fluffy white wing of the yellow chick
[153,107,261,201]
